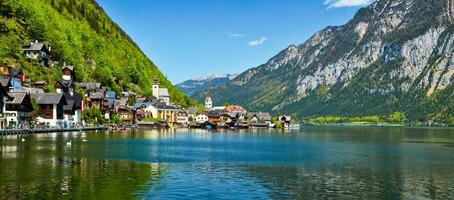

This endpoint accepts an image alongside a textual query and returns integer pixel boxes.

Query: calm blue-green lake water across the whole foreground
[0,128,454,199]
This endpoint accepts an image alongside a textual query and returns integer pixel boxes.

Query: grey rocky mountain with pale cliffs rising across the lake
[209,0,454,122]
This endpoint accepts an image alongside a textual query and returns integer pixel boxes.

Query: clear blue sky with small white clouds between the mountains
[97,0,370,83]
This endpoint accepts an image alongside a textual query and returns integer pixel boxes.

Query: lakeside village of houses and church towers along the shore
[0,41,291,130]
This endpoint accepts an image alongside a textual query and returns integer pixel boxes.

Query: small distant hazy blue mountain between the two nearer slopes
[175,74,238,96]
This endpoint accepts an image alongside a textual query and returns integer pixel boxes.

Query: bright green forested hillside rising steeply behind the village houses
[0,0,195,106]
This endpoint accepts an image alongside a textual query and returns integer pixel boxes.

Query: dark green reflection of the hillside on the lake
[0,133,167,199]
